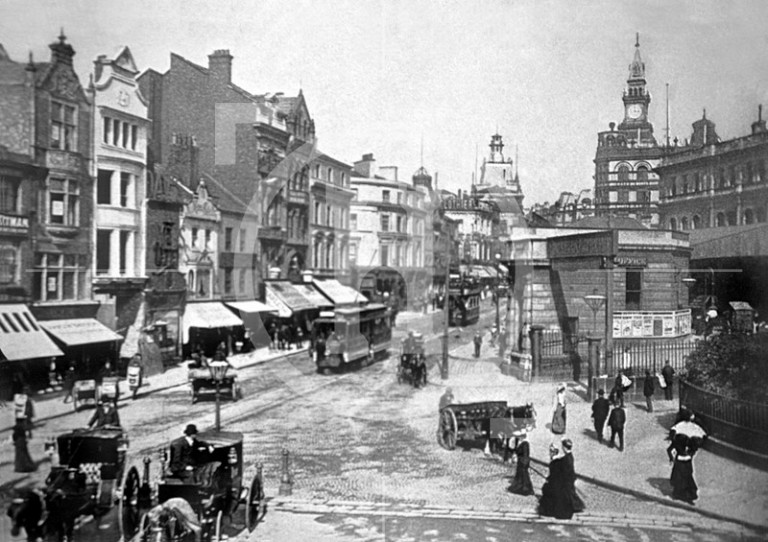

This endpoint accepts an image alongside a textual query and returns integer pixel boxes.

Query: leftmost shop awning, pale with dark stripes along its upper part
[0,304,64,361]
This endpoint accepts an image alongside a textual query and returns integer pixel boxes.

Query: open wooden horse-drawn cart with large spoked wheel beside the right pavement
[437,390,536,450]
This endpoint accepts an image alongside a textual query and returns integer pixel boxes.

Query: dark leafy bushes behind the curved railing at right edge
[686,333,768,403]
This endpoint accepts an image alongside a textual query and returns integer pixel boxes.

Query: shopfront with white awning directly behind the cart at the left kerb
[182,301,243,357]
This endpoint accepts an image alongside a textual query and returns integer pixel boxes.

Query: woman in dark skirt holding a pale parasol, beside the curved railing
[667,412,707,504]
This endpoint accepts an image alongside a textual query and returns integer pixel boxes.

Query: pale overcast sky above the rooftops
[0,0,768,204]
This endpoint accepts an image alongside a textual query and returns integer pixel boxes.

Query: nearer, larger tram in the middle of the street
[311,303,392,374]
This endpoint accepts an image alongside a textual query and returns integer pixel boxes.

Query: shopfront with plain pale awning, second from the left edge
[40,318,123,379]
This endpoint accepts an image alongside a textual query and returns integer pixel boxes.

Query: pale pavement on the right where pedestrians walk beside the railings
[430,344,768,532]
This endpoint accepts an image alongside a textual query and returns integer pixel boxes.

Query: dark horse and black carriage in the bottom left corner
[8,426,128,541]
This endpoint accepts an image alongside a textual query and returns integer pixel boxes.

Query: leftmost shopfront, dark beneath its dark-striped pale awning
[0,304,64,401]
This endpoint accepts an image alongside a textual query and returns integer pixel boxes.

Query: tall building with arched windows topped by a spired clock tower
[594,38,664,227]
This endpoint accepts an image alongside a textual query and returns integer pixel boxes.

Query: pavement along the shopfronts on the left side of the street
[0,346,308,434]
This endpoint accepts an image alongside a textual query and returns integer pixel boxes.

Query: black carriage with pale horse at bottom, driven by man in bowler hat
[119,432,266,542]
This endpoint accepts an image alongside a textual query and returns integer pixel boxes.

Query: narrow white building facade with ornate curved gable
[92,47,149,340]
